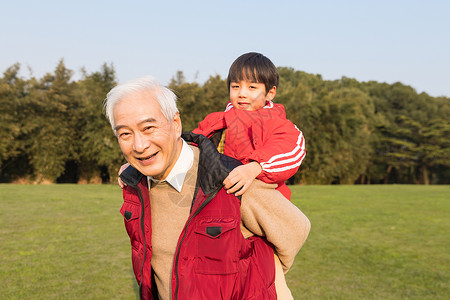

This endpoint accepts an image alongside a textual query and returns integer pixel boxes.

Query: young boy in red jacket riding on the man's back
[193,52,305,199]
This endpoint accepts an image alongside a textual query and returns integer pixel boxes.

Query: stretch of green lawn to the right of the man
[287,185,450,299]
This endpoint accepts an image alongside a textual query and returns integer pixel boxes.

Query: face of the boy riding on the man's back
[230,80,277,111]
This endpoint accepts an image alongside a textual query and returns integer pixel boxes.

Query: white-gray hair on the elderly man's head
[103,76,178,133]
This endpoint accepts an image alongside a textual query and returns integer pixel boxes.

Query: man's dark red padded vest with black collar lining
[120,133,277,300]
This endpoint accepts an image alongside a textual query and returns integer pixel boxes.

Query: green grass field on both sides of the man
[0,184,450,299]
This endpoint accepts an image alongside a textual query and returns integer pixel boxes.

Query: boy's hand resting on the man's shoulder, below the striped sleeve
[223,161,262,196]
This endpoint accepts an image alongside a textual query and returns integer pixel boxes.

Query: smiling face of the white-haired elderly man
[113,92,182,180]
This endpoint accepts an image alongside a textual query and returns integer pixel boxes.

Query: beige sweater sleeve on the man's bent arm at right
[241,180,311,272]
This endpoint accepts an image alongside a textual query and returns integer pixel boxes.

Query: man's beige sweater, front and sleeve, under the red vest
[150,147,310,299]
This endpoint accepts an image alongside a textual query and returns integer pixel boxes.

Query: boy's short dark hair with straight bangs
[227,52,279,94]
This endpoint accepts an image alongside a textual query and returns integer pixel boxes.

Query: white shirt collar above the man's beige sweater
[148,139,194,192]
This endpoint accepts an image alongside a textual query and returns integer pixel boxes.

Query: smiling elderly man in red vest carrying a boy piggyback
[105,77,310,299]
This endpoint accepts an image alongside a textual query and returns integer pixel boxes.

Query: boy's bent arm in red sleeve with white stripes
[247,120,306,183]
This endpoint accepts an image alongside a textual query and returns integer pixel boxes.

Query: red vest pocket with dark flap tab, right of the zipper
[194,217,240,274]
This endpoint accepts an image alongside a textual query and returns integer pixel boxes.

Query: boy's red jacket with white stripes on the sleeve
[193,102,306,199]
